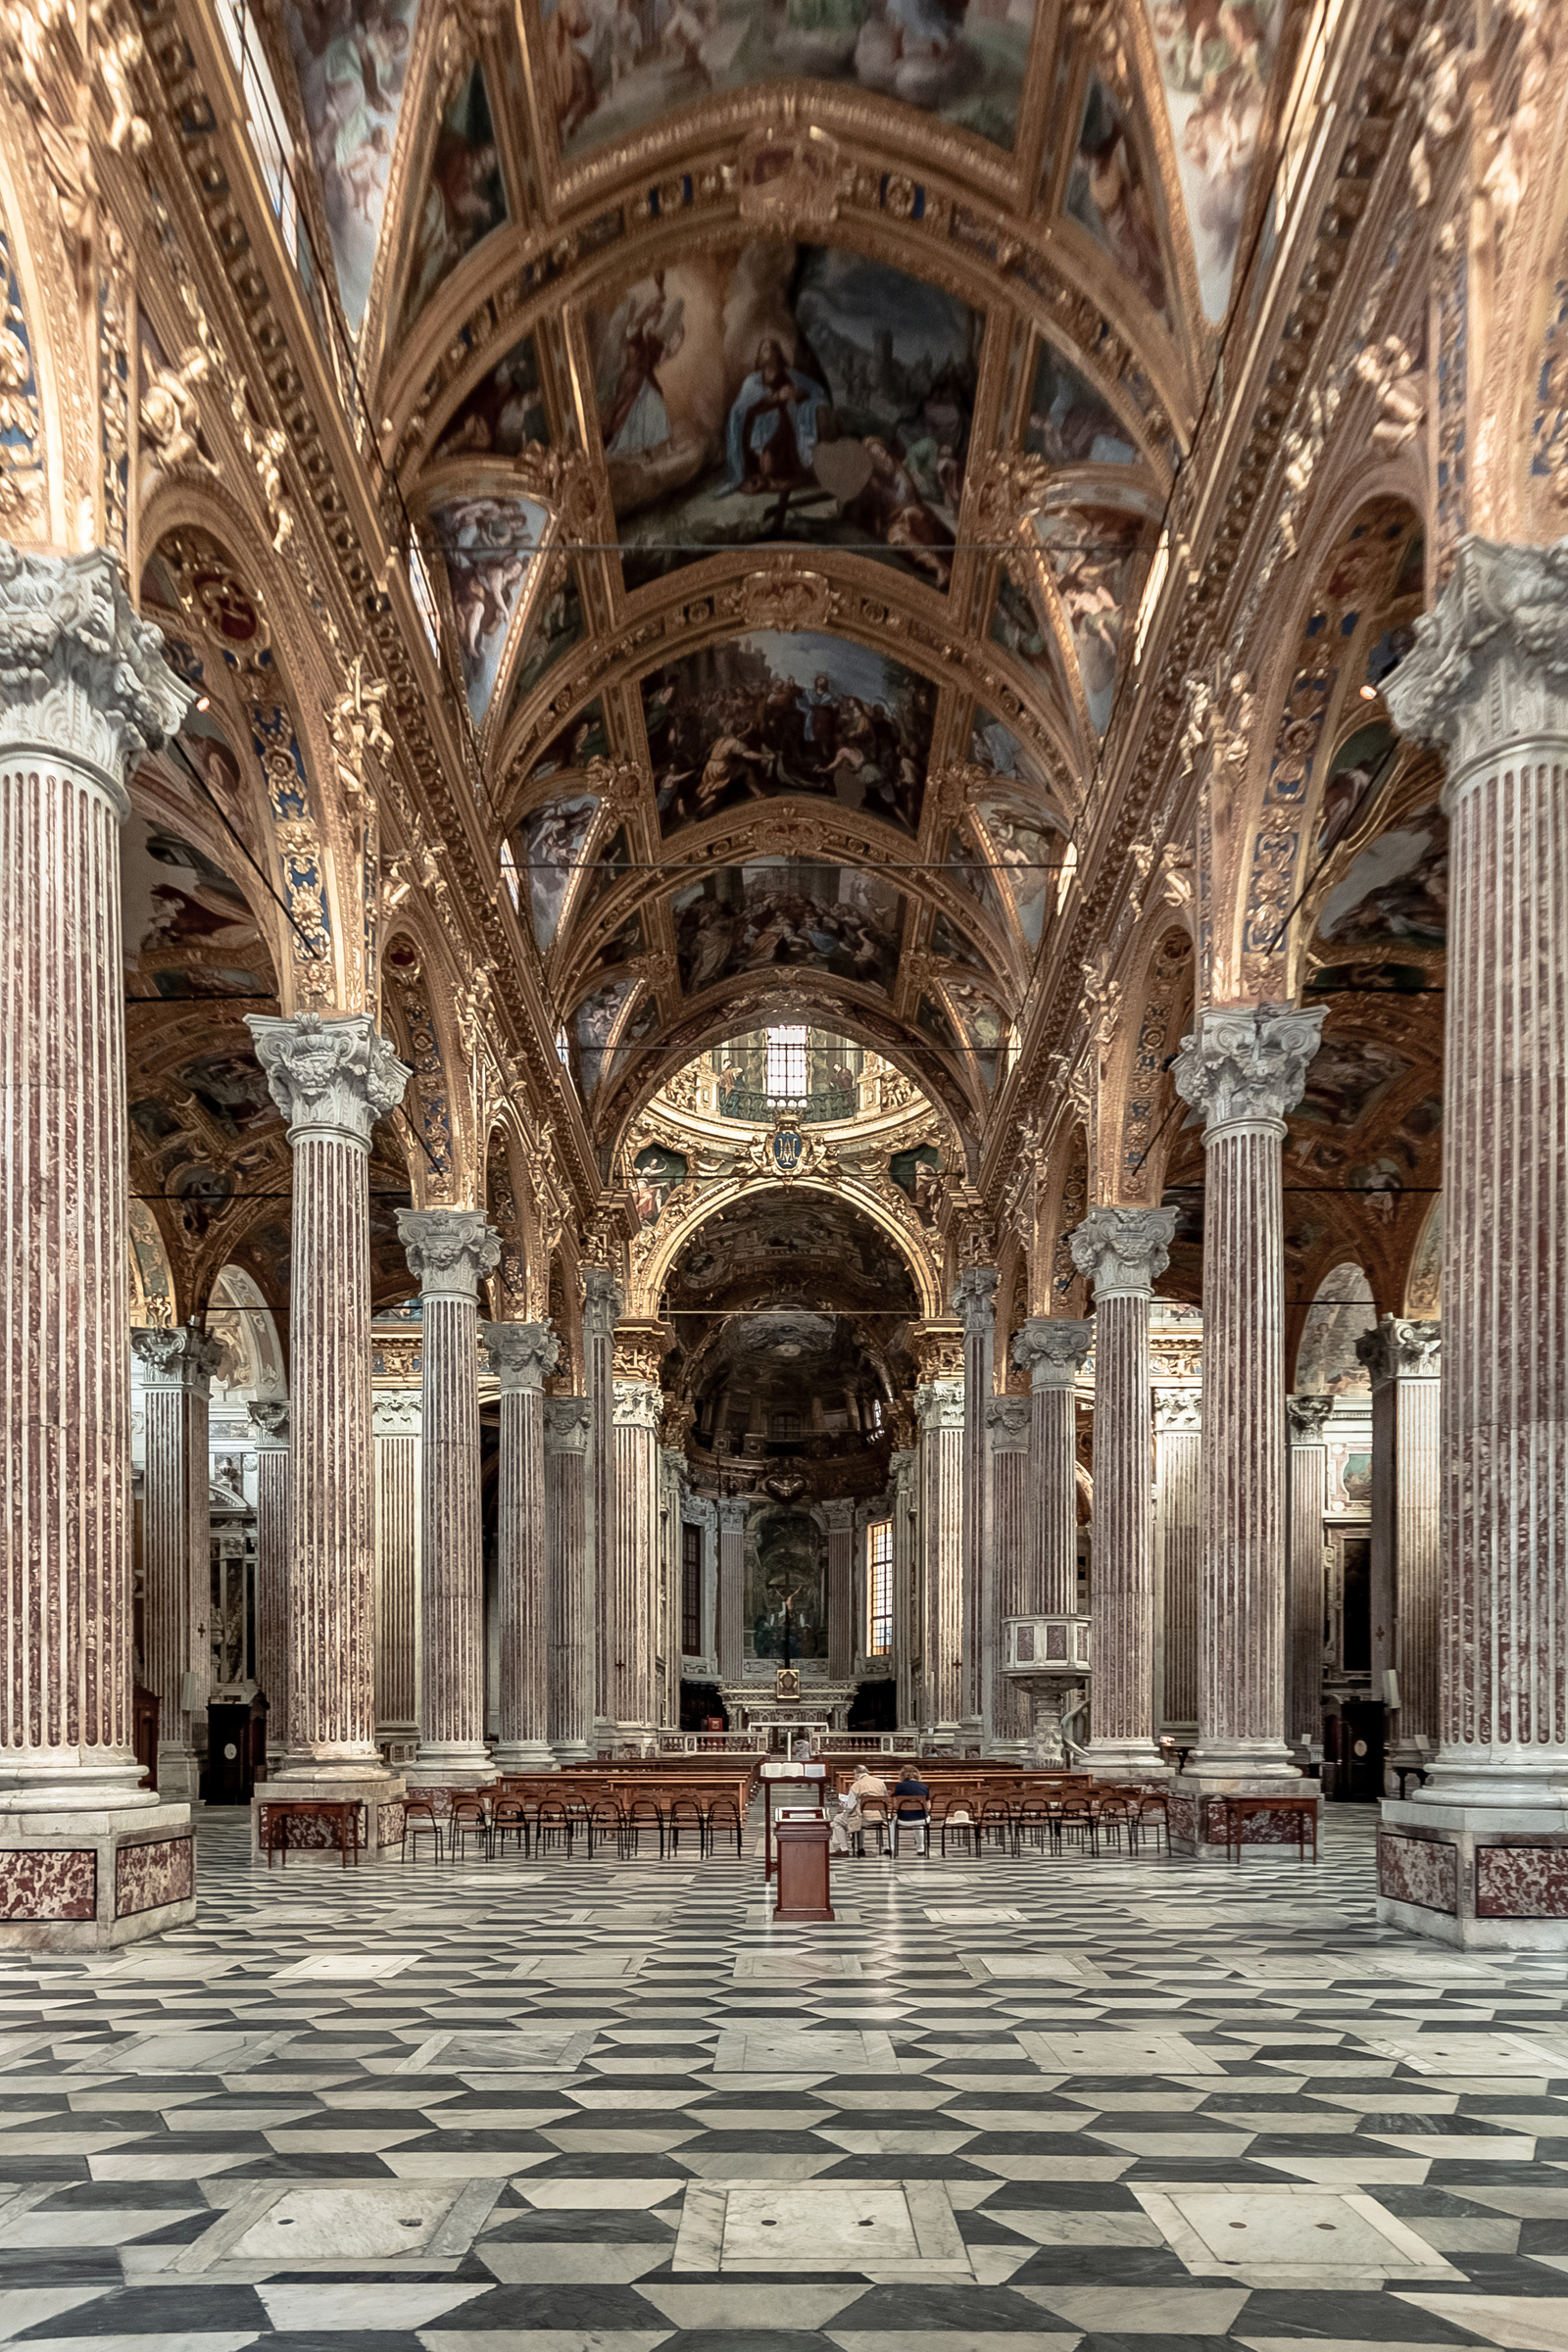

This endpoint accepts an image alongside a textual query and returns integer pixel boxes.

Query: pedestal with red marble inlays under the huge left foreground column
[0,1797,195,1952]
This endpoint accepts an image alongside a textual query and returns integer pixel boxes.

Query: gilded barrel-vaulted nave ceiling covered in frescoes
[267,0,1289,1166]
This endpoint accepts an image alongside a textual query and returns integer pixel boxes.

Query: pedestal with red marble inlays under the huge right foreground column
[1378,1788,1568,1952]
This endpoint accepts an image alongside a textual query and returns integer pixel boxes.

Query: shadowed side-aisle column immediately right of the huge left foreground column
[131,1324,223,1799]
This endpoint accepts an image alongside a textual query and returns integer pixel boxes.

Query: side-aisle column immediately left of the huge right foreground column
[1356,1315,1444,1766]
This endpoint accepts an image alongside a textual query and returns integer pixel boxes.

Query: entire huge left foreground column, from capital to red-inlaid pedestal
[0,541,195,1952]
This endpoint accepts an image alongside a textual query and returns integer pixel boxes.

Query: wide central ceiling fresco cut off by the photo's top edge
[538,0,1034,163]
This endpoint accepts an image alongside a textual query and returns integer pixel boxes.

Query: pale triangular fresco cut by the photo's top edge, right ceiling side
[1148,0,1286,319]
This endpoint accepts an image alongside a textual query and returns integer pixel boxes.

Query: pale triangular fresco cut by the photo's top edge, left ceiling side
[284,0,418,329]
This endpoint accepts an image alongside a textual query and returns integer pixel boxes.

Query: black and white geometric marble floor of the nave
[0,1809,1568,2352]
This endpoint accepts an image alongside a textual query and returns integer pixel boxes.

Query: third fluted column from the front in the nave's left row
[397,1209,501,1788]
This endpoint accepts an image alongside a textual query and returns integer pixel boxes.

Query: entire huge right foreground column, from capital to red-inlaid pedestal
[1378,539,1568,1952]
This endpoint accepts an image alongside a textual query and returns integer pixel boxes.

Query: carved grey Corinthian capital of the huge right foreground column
[1382,534,1568,786]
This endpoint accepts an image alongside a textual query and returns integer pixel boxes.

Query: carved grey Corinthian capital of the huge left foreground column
[0,539,190,816]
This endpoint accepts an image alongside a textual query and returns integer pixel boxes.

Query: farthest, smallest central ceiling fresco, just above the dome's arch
[670,858,906,995]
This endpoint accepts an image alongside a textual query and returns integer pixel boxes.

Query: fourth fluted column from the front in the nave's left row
[484,1322,562,1771]
